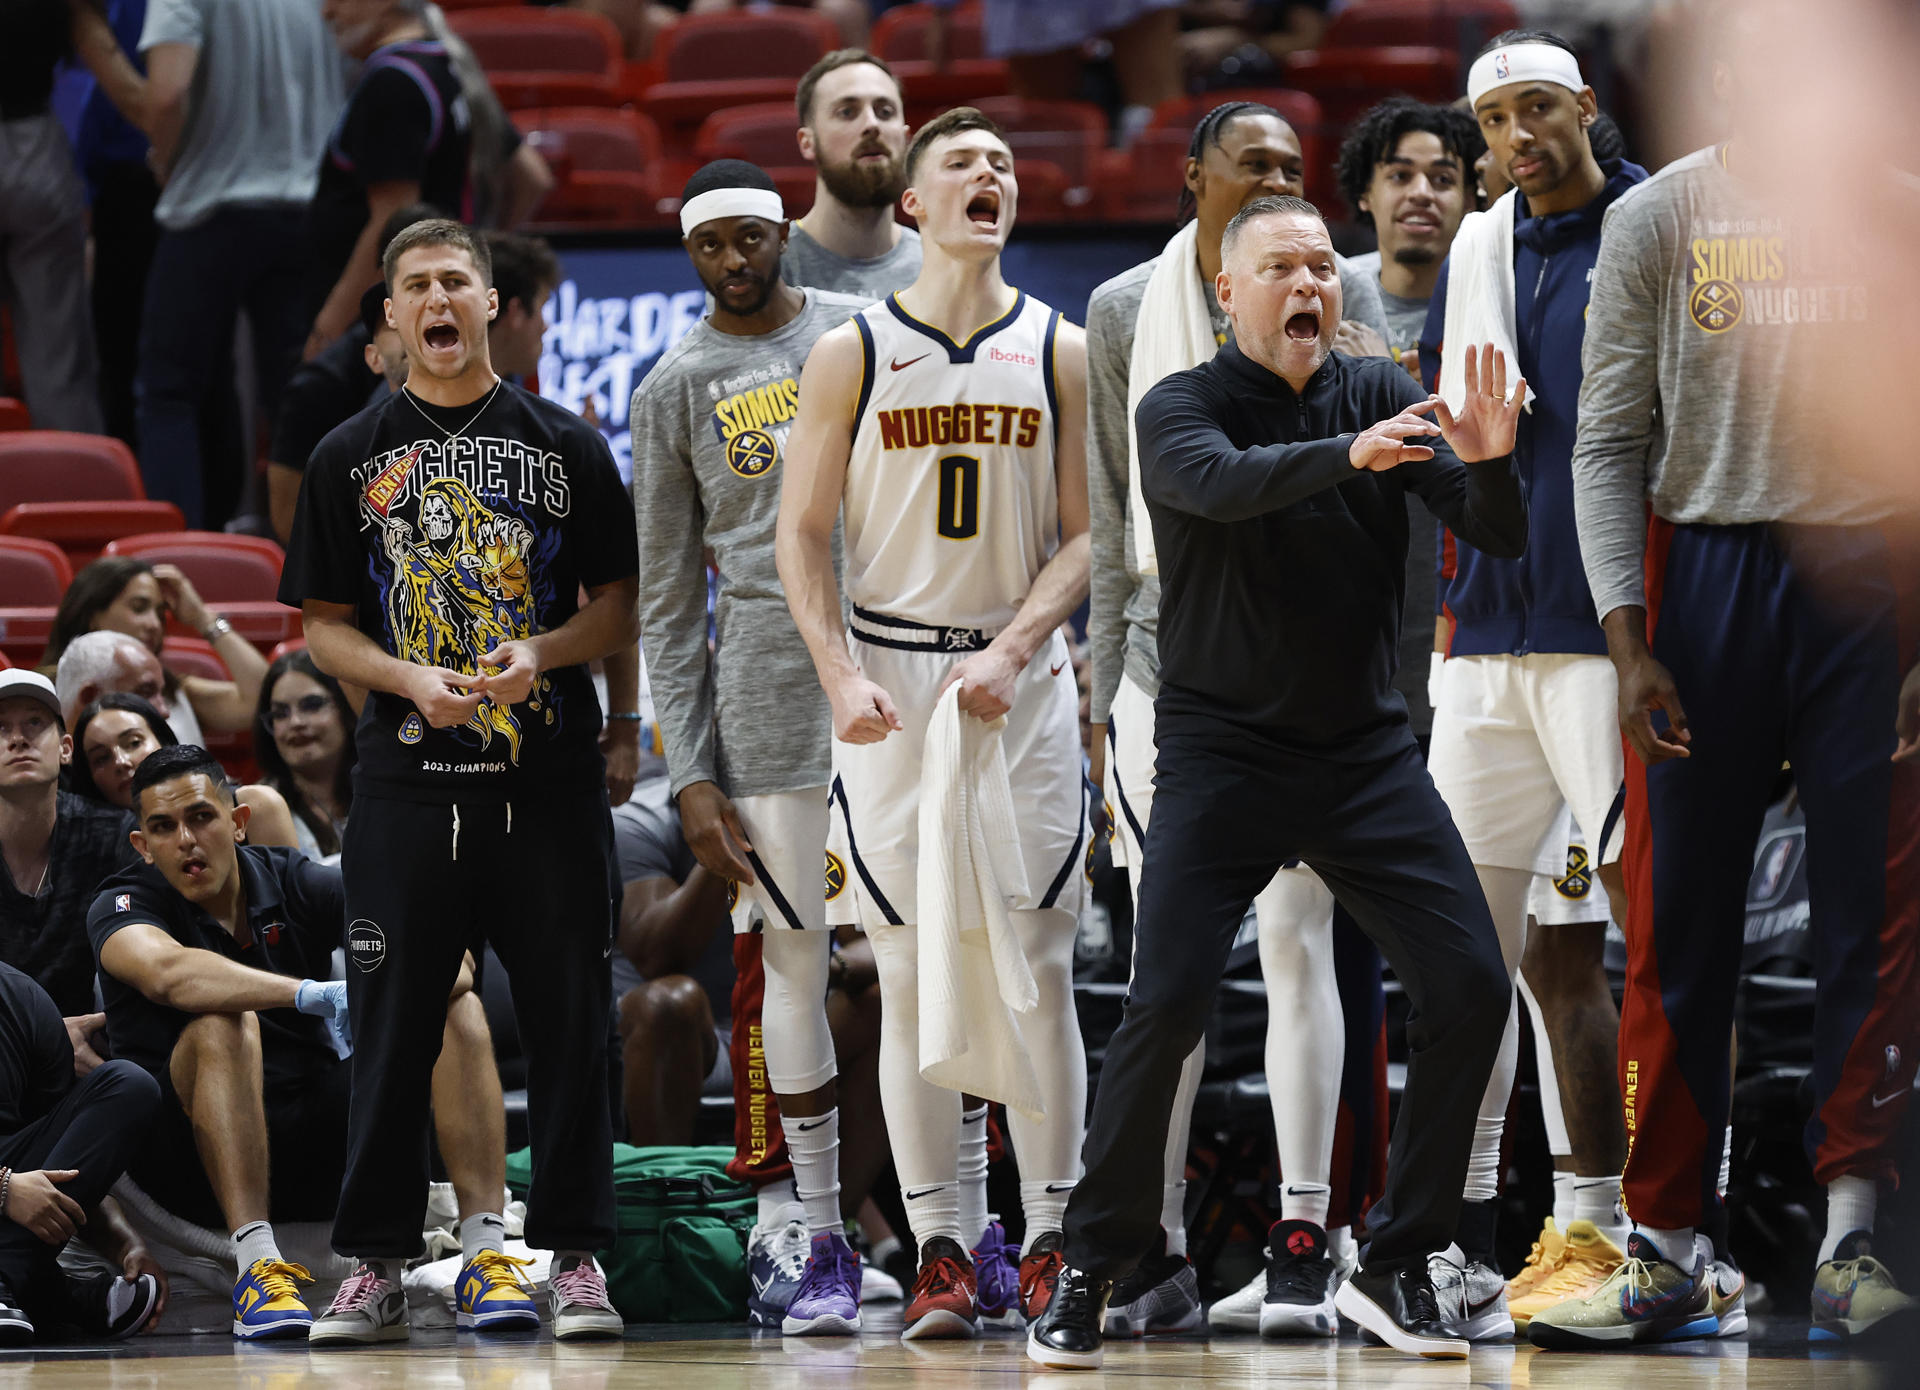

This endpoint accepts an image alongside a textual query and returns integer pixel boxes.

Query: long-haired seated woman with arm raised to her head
[42,555,267,743]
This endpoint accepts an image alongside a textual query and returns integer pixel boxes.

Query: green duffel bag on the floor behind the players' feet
[507,1144,755,1323]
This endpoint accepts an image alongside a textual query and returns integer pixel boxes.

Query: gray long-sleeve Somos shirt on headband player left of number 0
[632,290,868,797]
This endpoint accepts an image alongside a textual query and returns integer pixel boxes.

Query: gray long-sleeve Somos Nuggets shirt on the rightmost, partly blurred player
[1572,150,1893,618]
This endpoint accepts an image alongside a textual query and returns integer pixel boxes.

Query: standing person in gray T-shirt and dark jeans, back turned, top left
[138,0,344,528]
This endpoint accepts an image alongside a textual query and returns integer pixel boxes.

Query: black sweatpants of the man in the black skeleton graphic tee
[334,781,614,1259]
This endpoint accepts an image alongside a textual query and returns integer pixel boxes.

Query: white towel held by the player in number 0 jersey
[916,682,1046,1119]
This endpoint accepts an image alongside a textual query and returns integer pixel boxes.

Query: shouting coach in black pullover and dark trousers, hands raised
[1027,198,1526,1367]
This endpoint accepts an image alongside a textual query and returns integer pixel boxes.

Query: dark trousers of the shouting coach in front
[1066,718,1513,1279]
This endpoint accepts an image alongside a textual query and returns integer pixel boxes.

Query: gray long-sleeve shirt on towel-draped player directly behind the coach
[1087,255,1397,724]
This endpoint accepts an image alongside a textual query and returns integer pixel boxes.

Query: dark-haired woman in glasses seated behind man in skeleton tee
[253,649,359,858]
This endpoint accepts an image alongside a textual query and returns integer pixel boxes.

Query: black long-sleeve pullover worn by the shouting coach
[1135,342,1526,758]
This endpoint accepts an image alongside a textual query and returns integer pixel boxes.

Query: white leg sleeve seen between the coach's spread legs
[1254,868,1346,1198]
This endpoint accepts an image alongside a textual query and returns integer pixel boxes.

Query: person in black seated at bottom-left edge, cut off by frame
[0,964,167,1346]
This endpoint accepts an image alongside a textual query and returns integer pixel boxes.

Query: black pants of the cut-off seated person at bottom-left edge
[0,1062,159,1315]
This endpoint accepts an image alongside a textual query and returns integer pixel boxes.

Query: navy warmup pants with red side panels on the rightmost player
[1620,518,1920,1229]
